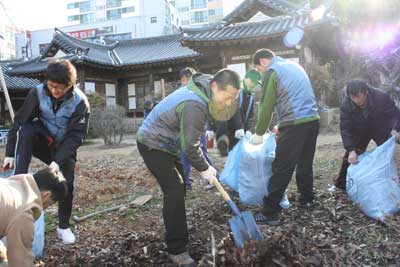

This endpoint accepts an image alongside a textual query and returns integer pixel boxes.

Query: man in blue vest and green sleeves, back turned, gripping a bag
[250,49,319,225]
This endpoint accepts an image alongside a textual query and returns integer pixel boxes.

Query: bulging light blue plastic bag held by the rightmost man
[346,136,400,222]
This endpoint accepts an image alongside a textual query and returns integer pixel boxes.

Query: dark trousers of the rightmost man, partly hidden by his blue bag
[334,132,390,190]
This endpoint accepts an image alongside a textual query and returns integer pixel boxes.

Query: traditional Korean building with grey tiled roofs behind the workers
[7,0,337,116]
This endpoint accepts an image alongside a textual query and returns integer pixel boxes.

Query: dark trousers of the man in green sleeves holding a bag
[262,121,319,216]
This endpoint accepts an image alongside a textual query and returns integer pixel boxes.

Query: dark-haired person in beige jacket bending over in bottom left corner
[0,167,68,267]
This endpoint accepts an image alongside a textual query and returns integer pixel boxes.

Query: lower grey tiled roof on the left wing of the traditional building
[10,29,200,75]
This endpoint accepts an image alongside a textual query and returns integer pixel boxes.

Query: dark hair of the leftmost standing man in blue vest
[47,59,76,88]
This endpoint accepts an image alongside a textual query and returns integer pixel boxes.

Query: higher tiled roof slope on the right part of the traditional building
[182,15,333,45]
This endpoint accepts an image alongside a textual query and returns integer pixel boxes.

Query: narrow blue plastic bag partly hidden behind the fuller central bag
[219,138,243,192]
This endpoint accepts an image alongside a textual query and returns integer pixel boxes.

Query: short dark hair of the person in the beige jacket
[33,167,68,202]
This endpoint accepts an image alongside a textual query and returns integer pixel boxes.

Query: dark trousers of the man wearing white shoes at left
[15,122,76,229]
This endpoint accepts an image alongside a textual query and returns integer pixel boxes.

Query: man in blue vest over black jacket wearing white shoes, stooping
[3,60,89,244]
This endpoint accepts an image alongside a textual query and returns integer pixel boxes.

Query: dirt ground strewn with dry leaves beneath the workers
[0,134,400,266]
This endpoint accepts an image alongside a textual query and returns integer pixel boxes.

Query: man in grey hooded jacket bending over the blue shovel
[137,69,240,266]
